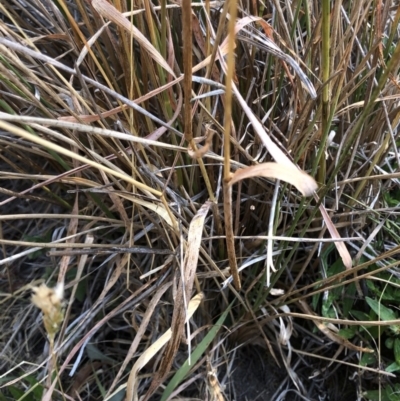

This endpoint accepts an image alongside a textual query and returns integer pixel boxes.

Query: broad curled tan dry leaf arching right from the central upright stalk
[229,162,318,196]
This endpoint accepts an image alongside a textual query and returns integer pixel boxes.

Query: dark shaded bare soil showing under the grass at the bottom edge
[221,345,357,401]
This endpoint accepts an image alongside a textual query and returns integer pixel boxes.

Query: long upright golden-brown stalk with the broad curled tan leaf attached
[223,0,241,291]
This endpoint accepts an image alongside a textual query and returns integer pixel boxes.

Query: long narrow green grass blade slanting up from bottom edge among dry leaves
[161,301,235,401]
